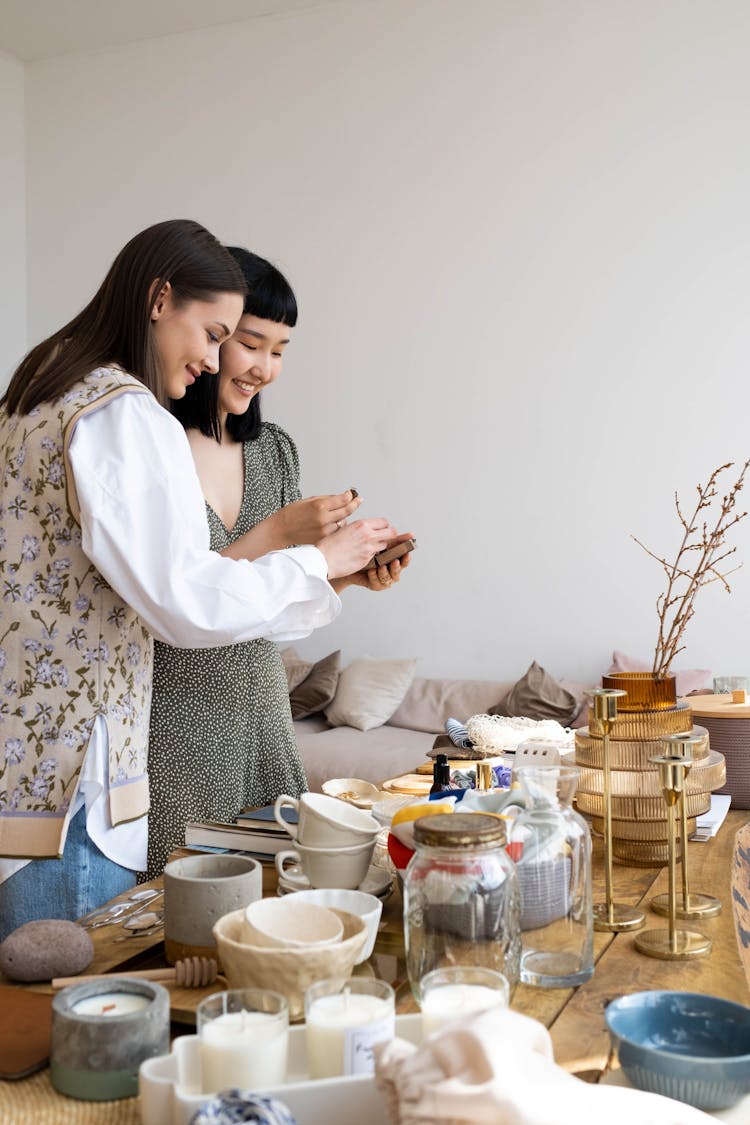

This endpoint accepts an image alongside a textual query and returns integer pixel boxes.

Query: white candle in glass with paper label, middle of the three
[307,991,395,1078]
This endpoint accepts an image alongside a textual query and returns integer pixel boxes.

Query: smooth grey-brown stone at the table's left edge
[0,918,93,981]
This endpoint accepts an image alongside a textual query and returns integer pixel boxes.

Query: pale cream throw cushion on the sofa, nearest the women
[325,657,417,730]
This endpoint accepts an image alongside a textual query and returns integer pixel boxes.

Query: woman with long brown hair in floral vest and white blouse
[0,214,394,938]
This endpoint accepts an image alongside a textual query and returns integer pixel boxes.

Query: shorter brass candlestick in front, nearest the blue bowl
[635,755,711,961]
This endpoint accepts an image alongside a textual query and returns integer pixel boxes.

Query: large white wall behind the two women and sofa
[20,0,750,678]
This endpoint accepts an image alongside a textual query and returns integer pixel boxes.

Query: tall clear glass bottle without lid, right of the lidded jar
[512,766,594,988]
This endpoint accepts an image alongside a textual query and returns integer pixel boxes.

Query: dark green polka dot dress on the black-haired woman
[143,422,307,879]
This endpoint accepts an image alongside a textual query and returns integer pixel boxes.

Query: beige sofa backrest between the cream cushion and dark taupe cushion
[388,677,510,745]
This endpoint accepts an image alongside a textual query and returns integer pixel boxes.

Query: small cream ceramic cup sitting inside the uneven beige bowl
[242,897,344,950]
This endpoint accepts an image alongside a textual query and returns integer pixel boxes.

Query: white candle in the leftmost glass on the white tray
[200,1011,289,1094]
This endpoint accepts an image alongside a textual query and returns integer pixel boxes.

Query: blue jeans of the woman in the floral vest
[0,808,136,942]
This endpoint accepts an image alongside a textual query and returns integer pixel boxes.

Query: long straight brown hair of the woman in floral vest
[2,219,245,414]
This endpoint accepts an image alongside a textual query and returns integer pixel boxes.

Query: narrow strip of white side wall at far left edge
[0,51,27,389]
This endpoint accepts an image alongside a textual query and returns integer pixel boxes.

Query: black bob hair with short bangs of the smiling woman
[170,246,297,441]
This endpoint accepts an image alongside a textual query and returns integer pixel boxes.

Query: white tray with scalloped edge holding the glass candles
[138,1015,422,1125]
